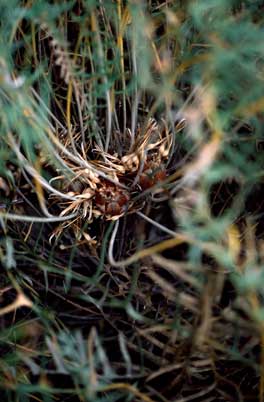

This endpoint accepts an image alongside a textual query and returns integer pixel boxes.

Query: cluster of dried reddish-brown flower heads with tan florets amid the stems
[51,119,172,240]
